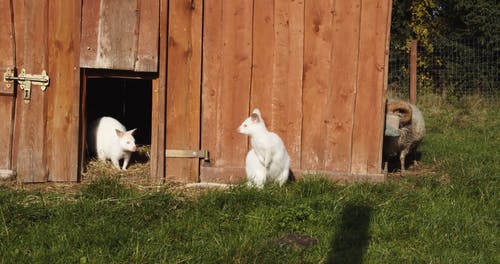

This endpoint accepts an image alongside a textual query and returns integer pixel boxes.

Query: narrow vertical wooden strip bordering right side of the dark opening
[150,0,169,182]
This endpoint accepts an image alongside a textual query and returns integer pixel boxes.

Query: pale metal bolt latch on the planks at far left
[3,69,49,103]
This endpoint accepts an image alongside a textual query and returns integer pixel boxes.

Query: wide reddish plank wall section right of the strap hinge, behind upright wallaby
[201,0,391,181]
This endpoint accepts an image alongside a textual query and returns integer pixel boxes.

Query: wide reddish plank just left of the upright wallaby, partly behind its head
[201,0,253,181]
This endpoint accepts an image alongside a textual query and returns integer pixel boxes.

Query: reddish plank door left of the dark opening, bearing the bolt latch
[0,0,80,182]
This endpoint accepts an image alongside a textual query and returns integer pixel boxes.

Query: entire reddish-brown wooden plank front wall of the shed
[0,0,391,182]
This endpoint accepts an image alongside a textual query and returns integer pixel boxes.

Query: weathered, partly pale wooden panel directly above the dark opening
[80,0,159,72]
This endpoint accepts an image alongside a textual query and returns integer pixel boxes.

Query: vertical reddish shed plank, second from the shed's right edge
[325,0,361,173]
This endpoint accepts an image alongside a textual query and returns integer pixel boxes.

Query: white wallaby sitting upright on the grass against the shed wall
[238,108,290,188]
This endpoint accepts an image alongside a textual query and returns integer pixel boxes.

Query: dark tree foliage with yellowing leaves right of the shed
[390,0,500,97]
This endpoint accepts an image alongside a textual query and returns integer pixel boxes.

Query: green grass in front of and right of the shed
[0,98,500,263]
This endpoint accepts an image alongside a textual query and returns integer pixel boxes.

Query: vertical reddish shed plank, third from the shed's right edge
[301,0,334,170]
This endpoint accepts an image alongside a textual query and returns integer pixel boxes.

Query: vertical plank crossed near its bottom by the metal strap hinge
[166,0,203,182]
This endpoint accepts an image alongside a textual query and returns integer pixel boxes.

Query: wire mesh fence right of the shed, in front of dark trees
[388,40,500,100]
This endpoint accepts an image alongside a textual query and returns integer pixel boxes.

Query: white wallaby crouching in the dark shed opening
[93,116,137,170]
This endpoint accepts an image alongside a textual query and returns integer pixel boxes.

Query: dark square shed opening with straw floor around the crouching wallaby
[81,71,152,181]
